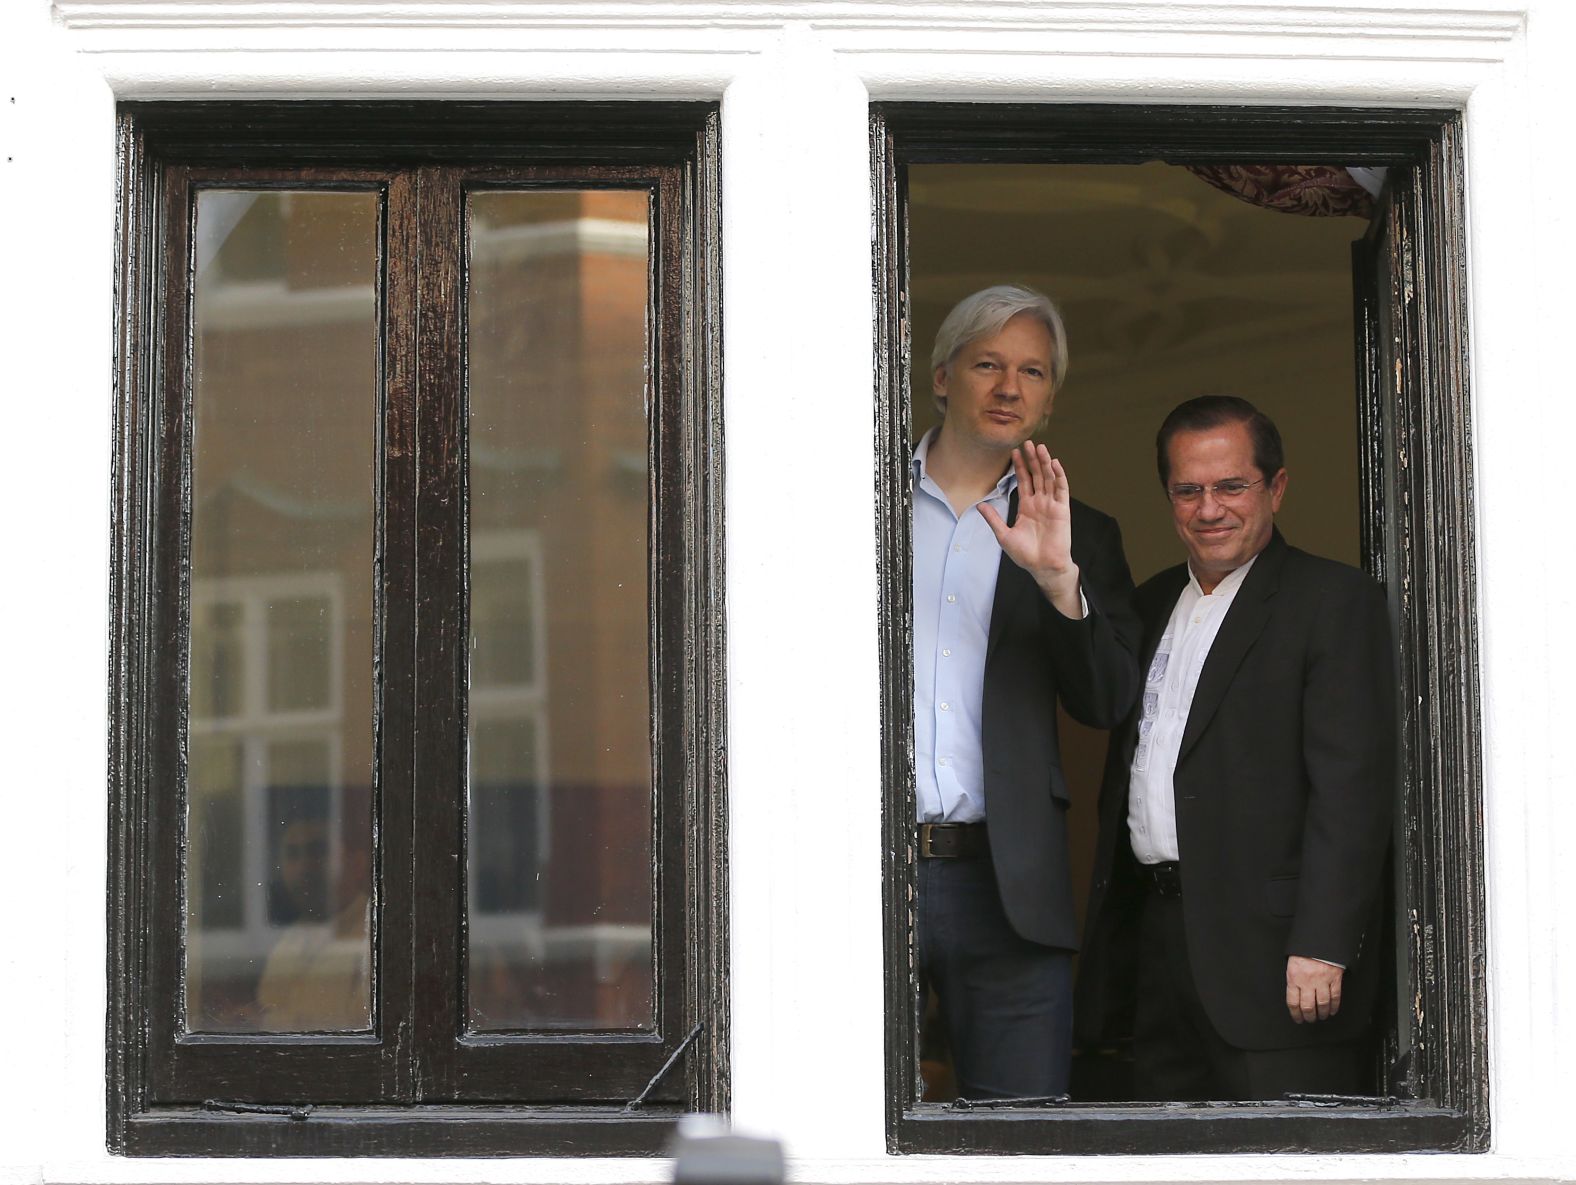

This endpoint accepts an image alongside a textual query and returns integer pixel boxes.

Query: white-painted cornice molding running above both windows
[54,0,1526,106]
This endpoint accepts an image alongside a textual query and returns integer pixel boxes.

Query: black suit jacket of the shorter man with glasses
[1078,531,1396,1049]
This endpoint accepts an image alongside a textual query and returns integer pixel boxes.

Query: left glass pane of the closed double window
[184,189,380,1032]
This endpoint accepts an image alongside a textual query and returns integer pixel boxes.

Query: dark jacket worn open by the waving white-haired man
[980,495,1139,950]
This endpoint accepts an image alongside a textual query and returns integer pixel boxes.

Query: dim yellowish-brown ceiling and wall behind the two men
[908,164,1366,577]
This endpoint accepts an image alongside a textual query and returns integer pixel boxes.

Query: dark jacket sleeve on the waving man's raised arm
[1040,511,1139,728]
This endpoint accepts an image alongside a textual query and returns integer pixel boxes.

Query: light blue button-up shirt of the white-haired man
[914,429,1018,823]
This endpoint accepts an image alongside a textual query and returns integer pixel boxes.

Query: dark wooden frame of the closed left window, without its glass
[107,102,728,1155]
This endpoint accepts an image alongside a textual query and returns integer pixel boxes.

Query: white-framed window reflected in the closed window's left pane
[184,572,372,1032]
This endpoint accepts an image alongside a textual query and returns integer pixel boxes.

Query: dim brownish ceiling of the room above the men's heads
[909,164,1363,403]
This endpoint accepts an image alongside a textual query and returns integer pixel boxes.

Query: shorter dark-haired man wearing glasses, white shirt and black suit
[1078,396,1396,1100]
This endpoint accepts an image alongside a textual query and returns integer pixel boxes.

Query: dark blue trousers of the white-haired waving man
[919,859,1073,1098]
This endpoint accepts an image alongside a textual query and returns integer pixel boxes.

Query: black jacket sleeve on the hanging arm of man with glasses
[1286,577,1396,968]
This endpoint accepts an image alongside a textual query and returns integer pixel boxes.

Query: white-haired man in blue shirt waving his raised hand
[913,285,1139,1098]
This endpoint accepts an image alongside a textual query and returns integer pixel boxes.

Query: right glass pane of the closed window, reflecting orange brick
[466,191,656,1031]
